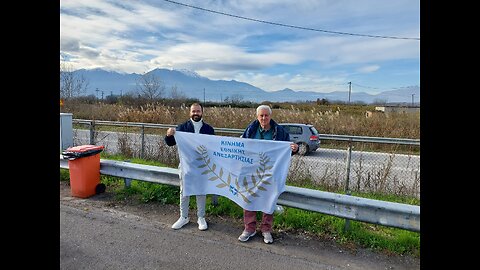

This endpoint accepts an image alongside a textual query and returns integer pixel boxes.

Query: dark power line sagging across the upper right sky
[164,0,420,40]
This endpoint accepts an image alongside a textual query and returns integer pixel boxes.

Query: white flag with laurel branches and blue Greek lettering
[175,131,292,214]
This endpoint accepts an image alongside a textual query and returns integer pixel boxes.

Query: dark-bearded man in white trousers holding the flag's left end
[165,103,215,231]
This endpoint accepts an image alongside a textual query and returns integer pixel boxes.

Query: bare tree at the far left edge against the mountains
[60,61,88,100]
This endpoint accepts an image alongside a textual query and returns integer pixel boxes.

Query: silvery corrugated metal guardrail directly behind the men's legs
[60,155,420,232]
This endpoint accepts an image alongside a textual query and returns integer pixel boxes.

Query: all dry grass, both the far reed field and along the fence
[62,100,420,198]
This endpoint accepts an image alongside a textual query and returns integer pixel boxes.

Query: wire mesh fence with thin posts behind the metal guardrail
[73,120,420,198]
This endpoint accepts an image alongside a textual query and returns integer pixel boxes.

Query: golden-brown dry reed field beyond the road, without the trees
[62,103,420,139]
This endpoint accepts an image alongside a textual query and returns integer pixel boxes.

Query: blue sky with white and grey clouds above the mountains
[60,0,420,94]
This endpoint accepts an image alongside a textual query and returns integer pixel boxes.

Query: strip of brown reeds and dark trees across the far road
[61,96,420,154]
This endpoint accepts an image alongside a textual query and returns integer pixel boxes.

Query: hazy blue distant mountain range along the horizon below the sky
[73,69,420,105]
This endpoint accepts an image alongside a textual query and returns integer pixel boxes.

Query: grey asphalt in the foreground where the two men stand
[60,182,420,270]
